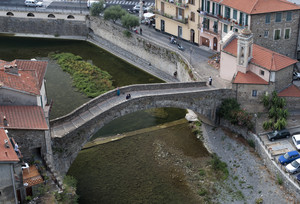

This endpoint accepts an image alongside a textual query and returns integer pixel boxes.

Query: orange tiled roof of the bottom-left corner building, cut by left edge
[0,128,19,163]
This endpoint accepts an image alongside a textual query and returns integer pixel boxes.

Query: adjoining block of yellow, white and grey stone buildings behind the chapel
[155,0,300,58]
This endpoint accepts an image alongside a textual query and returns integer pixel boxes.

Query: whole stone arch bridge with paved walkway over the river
[50,82,234,175]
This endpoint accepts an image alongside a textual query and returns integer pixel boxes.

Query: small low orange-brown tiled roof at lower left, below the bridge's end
[23,165,44,187]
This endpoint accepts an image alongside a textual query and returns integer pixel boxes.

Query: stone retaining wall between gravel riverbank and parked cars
[220,119,300,200]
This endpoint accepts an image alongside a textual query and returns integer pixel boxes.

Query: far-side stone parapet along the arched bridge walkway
[50,82,206,127]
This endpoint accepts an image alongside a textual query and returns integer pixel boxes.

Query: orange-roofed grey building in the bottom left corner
[0,128,21,203]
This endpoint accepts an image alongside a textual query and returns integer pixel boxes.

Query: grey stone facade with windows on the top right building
[250,10,300,58]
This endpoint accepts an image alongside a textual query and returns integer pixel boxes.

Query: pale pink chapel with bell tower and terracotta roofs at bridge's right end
[220,29,297,112]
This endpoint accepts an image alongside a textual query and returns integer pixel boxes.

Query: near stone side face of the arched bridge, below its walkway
[52,89,232,175]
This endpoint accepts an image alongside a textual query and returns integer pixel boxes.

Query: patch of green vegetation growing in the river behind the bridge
[50,53,114,98]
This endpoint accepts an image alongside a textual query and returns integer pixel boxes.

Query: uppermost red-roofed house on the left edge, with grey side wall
[0,60,48,108]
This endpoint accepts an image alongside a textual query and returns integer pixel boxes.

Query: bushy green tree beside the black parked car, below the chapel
[262,91,288,130]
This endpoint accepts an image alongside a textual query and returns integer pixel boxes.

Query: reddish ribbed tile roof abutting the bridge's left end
[0,106,48,130]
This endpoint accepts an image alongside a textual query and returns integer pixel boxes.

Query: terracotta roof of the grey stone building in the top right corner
[221,0,300,14]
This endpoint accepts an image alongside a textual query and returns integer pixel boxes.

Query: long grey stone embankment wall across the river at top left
[0,16,88,36]
